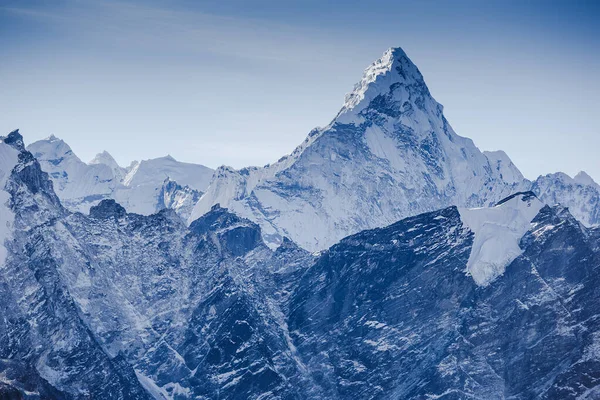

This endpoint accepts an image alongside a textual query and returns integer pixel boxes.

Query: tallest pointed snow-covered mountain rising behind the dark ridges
[190,48,529,251]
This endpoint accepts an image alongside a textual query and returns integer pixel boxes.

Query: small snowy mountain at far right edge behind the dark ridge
[531,171,600,226]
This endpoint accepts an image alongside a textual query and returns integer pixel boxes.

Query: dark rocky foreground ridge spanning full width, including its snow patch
[0,132,600,399]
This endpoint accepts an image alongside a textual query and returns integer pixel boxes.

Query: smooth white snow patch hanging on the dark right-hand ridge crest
[459,192,544,286]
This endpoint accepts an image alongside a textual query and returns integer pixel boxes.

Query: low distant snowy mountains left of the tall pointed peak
[27,136,213,219]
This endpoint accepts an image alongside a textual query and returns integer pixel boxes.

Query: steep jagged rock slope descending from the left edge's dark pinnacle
[0,132,150,399]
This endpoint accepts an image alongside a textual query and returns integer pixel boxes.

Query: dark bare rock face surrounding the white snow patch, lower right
[288,198,600,399]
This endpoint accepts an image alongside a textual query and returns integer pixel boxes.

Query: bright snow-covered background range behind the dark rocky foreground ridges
[28,48,600,251]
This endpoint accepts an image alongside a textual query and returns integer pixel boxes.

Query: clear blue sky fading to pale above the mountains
[0,0,600,181]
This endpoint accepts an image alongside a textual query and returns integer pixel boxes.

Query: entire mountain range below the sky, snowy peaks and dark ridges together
[0,49,600,399]
